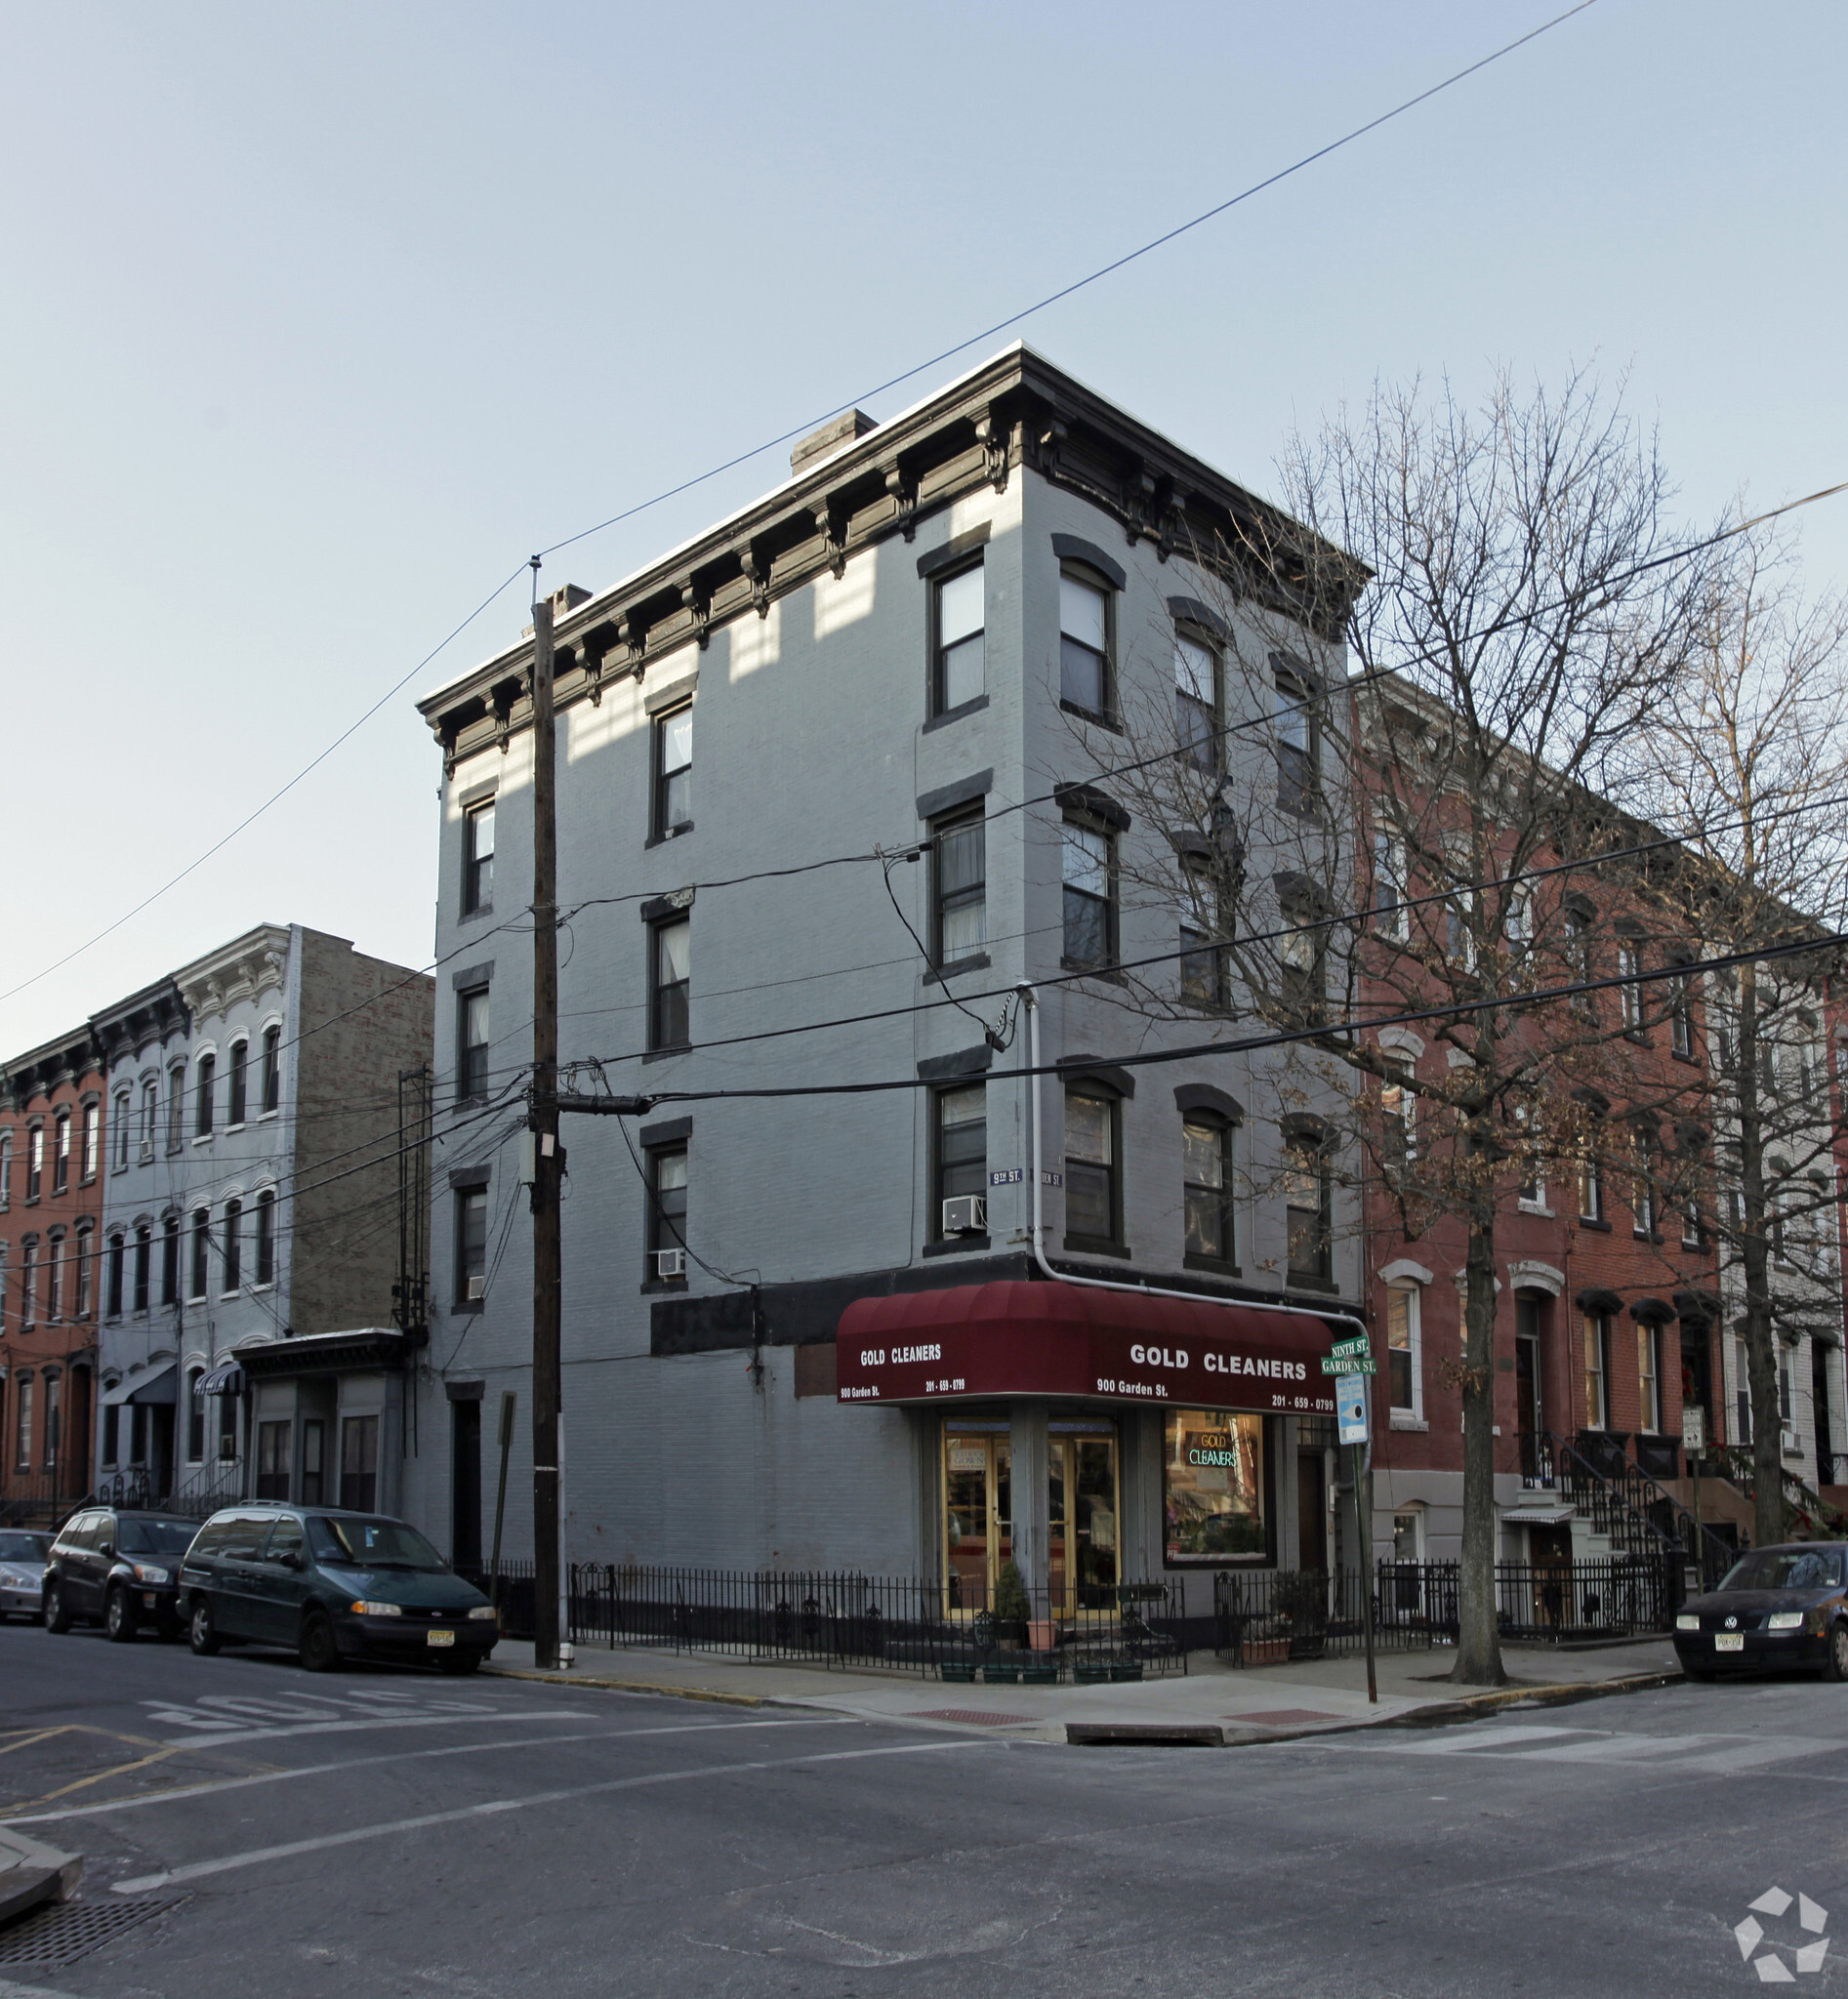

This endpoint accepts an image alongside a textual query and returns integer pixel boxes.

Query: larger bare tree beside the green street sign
[1072,376,1690,1683]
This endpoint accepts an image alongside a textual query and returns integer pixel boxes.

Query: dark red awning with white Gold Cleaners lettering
[834,1282,1334,1415]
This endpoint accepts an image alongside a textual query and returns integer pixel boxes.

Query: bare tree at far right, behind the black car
[1634,528,1848,1545]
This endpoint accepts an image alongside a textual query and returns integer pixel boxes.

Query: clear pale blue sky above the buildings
[0,0,1848,1053]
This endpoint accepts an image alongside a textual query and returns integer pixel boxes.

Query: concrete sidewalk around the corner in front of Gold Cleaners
[486,1637,1680,1743]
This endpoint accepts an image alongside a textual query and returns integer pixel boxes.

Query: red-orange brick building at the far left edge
[0,1028,104,1524]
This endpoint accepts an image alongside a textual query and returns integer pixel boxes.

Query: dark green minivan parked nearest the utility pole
[180,1505,500,1673]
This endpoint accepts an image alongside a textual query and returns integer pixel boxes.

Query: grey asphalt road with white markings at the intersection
[0,1625,1848,1999]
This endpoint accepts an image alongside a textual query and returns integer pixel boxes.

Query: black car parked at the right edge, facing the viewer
[1674,1541,1848,1679]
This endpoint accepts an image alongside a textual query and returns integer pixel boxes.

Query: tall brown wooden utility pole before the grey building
[532,579,564,1667]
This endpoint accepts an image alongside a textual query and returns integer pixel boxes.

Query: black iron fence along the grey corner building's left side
[468,1561,1210,1685]
